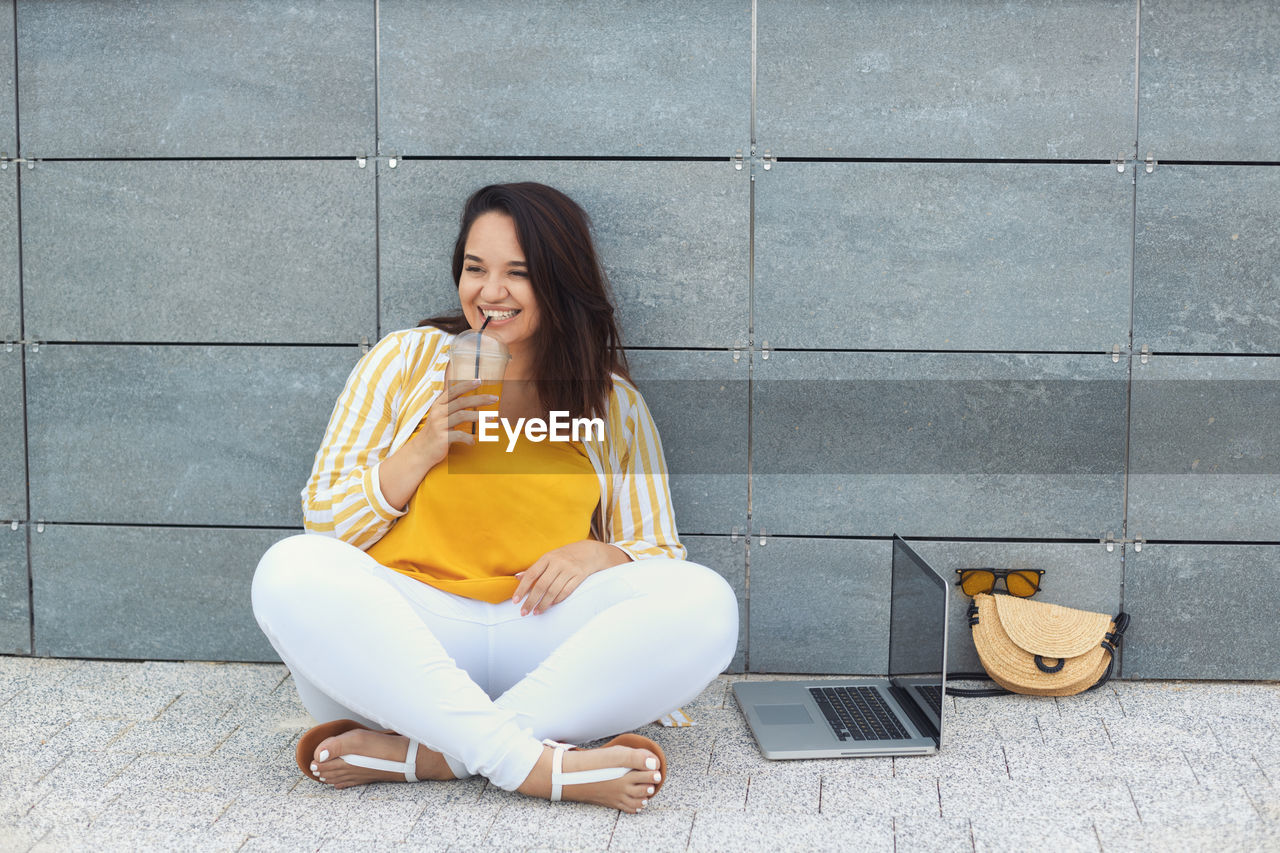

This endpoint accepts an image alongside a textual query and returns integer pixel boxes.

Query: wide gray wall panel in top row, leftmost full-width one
[18,0,376,158]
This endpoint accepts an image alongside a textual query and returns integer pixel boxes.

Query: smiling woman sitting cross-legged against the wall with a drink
[253,183,737,813]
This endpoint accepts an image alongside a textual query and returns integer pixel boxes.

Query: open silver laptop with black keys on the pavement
[733,537,948,758]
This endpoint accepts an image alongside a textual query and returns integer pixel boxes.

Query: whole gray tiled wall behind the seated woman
[0,0,1280,678]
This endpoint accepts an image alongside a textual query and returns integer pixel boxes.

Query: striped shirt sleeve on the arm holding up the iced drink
[302,327,406,548]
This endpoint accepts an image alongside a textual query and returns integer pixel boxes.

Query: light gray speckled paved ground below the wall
[0,657,1280,853]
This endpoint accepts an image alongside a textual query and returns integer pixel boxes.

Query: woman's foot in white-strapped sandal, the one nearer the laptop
[517,745,662,815]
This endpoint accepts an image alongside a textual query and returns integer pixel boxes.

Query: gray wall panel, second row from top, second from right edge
[755,163,1133,352]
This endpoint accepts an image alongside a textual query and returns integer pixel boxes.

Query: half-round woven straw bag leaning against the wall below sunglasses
[969,593,1129,695]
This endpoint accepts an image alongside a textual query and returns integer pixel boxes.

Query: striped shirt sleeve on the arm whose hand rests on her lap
[607,383,687,560]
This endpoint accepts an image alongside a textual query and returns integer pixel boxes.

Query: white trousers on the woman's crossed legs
[253,534,737,790]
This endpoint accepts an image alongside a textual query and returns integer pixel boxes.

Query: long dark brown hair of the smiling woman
[419,183,630,418]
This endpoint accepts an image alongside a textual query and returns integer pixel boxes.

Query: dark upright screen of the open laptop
[888,537,947,717]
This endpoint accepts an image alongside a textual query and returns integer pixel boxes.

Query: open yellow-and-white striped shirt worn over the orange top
[302,327,686,560]
